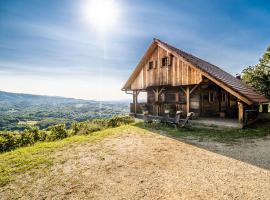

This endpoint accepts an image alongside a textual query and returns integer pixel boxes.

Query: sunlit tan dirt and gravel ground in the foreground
[0,128,270,199]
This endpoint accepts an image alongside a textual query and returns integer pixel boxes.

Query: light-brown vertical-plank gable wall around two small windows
[131,46,202,90]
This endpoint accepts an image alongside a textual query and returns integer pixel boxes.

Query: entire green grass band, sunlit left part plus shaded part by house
[0,115,270,187]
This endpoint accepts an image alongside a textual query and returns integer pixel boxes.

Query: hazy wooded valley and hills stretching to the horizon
[0,91,129,131]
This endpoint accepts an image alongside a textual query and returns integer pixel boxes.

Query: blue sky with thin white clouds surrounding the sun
[0,0,270,100]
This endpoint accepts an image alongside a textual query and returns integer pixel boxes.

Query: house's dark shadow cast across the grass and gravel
[135,114,270,170]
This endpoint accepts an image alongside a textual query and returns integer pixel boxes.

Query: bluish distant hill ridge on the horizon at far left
[0,91,95,106]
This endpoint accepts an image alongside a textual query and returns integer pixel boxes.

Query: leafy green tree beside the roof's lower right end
[242,46,270,98]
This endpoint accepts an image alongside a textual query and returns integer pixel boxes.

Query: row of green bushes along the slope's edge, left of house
[0,116,135,152]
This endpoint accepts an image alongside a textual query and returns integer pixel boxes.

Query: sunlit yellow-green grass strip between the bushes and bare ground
[0,125,130,187]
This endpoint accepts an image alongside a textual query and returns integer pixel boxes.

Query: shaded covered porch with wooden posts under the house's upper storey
[130,85,258,128]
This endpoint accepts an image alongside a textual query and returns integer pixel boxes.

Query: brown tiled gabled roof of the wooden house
[124,39,270,104]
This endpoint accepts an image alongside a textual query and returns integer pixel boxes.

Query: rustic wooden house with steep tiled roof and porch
[122,39,269,126]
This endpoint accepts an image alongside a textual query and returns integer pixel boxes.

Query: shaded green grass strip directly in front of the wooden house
[137,114,270,143]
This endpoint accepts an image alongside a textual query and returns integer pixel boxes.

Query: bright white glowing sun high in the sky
[83,0,119,31]
